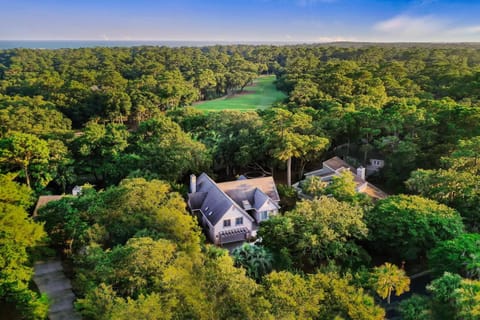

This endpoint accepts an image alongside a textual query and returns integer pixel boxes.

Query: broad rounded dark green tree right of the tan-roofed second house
[366,195,463,260]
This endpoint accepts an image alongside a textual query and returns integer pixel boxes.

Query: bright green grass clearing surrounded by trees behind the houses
[195,76,286,111]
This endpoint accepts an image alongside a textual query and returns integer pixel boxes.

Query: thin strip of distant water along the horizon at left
[0,40,292,50]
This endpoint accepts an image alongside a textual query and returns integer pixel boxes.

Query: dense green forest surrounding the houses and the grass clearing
[0,44,480,320]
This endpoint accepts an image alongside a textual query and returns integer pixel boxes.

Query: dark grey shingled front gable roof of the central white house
[188,173,253,225]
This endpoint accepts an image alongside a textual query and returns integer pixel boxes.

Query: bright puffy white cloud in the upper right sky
[373,15,446,40]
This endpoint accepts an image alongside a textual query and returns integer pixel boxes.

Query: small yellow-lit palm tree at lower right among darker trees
[372,262,410,304]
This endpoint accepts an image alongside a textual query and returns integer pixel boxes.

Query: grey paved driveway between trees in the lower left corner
[33,259,82,320]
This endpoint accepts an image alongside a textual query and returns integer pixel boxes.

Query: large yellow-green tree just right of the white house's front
[258,197,367,270]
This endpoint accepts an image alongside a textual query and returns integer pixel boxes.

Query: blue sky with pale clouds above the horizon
[0,0,480,42]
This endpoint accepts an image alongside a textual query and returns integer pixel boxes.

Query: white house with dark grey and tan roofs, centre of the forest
[188,173,280,245]
